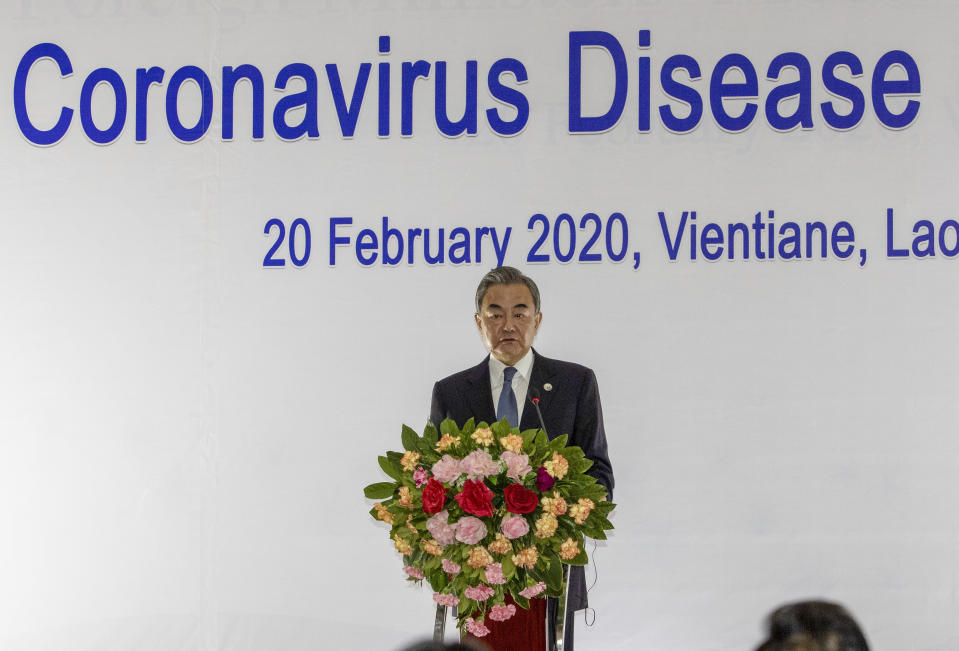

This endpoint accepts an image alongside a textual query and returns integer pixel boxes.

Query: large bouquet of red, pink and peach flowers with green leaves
[364,419,614,637]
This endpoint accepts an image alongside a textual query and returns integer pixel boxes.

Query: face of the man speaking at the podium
[475,283,543,366]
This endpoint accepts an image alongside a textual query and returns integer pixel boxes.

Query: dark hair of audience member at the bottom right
[756,601,869,651]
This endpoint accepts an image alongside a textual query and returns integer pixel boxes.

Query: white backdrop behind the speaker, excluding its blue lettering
[0,0,959,651]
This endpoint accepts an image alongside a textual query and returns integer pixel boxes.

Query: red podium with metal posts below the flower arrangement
[433,564,569,651]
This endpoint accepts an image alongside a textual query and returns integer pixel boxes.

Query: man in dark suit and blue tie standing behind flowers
[430,267,613,651]
